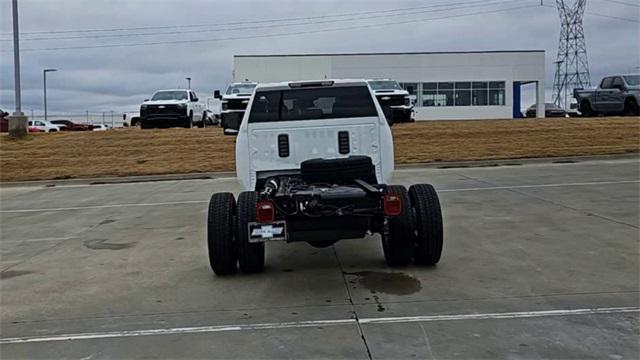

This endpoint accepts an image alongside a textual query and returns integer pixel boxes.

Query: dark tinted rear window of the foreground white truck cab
[249,86,378,123]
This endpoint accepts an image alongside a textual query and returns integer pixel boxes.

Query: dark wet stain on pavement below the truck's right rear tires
[345,271,422,295]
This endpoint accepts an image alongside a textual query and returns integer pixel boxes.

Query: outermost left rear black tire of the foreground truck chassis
[207,193,238,275]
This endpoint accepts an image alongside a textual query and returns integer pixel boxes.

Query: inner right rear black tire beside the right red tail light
[382,185,414,266]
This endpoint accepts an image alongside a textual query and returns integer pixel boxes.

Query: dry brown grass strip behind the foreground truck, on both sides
[0,117,640,182]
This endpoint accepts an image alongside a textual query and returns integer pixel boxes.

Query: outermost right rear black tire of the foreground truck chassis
[409,184,444,265]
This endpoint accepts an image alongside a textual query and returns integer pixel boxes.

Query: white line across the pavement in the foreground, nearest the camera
[0,307,640,345]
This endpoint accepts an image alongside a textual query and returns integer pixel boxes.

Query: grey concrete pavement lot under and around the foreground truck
[0,159,640,360]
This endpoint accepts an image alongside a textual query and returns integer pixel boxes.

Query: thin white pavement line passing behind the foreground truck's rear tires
[0,178,640,213]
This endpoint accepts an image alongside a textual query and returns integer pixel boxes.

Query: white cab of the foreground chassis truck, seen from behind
[236,80,394,190]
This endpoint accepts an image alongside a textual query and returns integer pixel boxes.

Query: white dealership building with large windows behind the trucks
[233,50,545,120]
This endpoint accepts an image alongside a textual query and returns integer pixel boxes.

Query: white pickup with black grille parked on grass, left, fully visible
[140,89,206,129]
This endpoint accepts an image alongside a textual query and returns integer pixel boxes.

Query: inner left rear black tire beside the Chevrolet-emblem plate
[236,191,264,273]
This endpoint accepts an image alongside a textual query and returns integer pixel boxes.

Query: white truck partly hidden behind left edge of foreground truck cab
[213,82,258,135]
